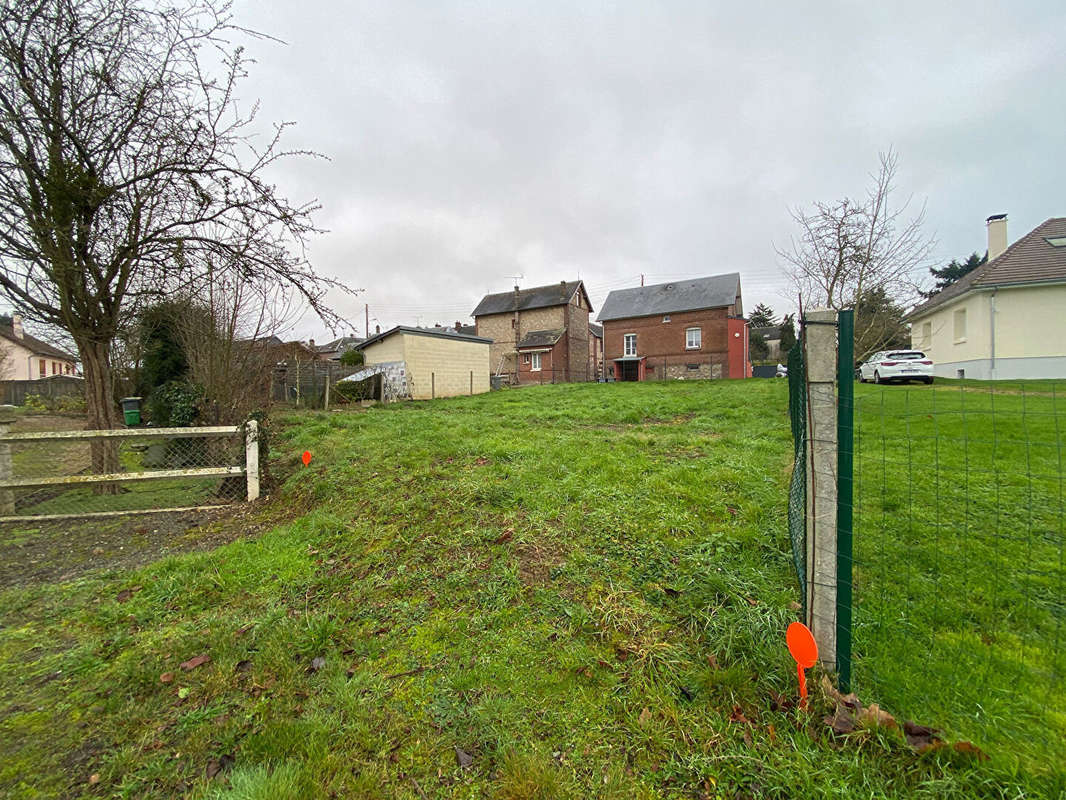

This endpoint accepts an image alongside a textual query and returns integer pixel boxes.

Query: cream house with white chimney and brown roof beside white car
[907,214,1066,380]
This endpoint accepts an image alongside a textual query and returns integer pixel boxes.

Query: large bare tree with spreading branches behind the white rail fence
[0,0,336,469]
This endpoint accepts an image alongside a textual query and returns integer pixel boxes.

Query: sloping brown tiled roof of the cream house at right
[906,217,1066,319]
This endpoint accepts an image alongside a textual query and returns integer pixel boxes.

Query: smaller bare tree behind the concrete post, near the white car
[776,150,934,353]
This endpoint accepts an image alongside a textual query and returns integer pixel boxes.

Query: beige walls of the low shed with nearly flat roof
[364,333,489,400]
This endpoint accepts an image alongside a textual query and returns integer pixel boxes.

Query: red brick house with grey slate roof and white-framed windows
[598,272,752,381]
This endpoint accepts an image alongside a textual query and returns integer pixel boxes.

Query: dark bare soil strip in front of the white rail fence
[0,507,256,589]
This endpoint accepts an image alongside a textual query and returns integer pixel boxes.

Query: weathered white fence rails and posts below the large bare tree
[0,419,259,522]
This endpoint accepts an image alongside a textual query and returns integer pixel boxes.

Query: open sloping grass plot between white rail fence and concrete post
[0,381,1064,800]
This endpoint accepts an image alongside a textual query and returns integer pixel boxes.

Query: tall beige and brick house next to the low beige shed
[472,281,594,383]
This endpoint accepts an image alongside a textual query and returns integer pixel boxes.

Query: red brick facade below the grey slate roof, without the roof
[603,307,747,381]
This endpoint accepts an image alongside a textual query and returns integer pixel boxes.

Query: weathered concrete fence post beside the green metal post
[803,308,837,670]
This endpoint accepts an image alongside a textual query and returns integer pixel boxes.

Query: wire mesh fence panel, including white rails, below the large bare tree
[0,418,255,521]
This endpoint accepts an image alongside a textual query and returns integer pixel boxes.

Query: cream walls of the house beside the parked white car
[910,285,1066,378]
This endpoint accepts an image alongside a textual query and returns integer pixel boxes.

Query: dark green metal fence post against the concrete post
[837,309,855,692]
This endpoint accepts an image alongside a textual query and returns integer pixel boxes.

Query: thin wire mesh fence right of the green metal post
[853,382,1066,764]
